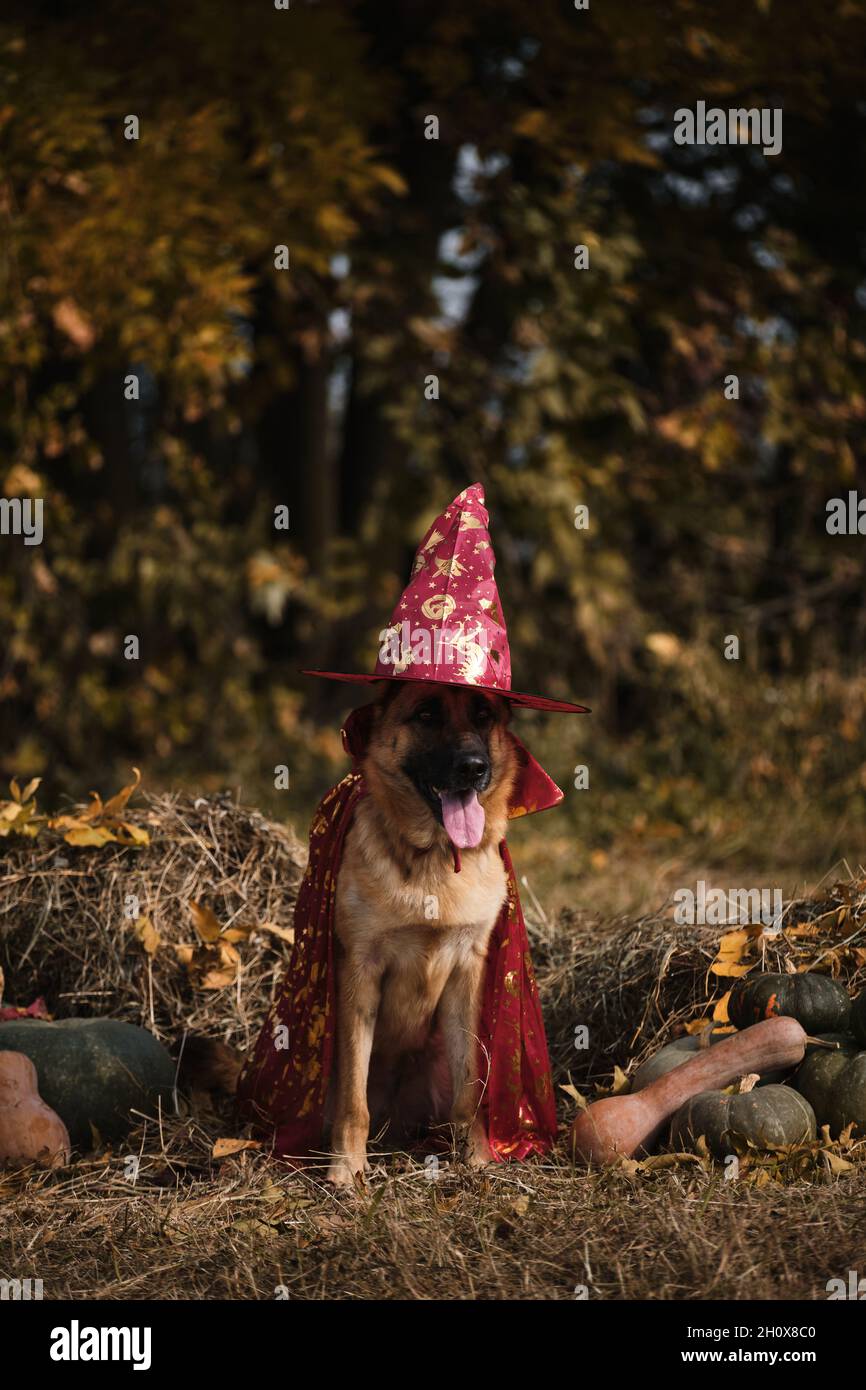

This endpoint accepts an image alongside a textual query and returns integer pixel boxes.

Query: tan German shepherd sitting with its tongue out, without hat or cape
[328,681,517,1186]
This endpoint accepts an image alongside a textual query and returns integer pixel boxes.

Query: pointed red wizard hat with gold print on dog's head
[303,482,589,714]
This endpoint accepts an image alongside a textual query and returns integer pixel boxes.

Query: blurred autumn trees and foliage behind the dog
[0,0,866,901]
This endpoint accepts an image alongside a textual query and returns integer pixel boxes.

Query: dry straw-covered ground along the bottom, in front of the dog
[0,1123,866,1300]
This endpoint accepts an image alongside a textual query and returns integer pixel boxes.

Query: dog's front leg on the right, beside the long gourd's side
[439,951,493,1168]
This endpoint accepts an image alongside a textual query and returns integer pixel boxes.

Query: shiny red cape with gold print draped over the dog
[238,710,562,1161]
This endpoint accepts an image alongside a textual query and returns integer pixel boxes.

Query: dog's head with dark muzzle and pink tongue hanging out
[364,681,516,849]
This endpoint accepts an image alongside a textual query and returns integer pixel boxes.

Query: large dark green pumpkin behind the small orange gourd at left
[0,1019,175,1150]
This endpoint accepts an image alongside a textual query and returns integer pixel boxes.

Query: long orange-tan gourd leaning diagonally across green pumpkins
[571,1017,806,1163]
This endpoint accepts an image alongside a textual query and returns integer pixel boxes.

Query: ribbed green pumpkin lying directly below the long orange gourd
[670,1086,817,1158]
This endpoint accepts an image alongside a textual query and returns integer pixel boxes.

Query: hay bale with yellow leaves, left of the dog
[0,794,306,1047]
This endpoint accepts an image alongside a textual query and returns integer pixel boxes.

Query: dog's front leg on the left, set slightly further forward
[328,952,382,1187]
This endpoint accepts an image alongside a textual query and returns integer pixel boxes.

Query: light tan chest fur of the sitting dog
[336,802,506,1055]
